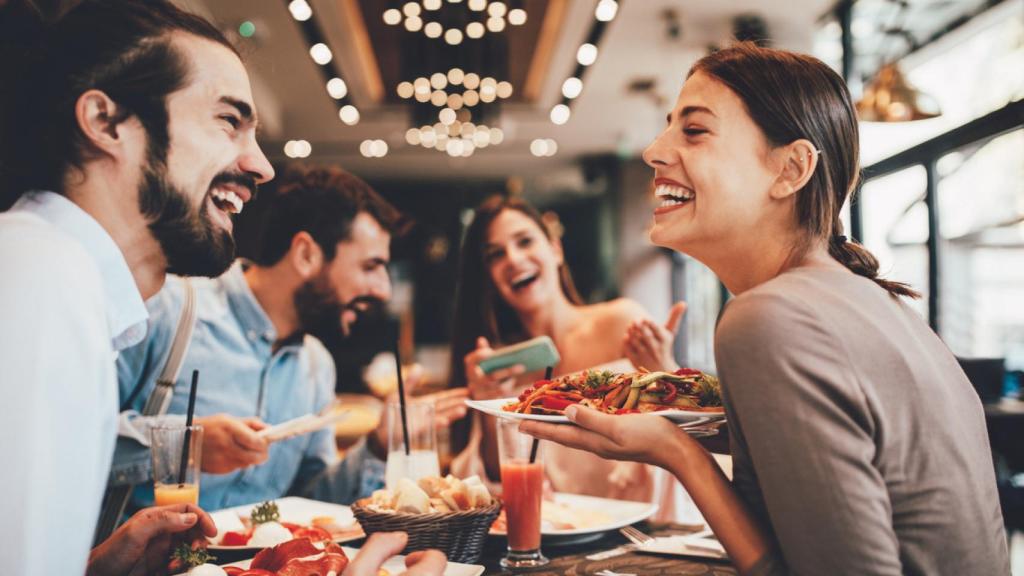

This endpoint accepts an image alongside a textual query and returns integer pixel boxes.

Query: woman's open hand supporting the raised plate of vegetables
[519,406,693,468]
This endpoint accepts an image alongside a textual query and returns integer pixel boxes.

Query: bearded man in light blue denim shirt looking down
[114,163,465,510]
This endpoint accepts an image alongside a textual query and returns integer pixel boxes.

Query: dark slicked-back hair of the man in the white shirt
[0,0,238,209]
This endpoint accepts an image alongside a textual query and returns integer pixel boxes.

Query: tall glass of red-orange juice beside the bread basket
[498,418,548,568]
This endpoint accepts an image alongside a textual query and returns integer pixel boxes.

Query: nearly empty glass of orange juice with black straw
[150,425,203,506]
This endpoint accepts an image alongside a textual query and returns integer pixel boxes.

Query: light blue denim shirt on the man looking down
[112,261,383,510]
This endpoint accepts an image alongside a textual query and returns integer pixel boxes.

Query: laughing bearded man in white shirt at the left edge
[0,0,273,574]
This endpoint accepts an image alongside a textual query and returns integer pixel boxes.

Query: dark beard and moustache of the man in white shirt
[138,159,246,277]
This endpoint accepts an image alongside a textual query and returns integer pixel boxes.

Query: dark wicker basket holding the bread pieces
[352,498,502,564]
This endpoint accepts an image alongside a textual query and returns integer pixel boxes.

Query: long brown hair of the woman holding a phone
[450,196,583,387]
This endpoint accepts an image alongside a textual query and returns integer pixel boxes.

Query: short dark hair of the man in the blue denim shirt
[254,165,411,266]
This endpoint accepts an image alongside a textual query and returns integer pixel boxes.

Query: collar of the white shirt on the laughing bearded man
[11,191,150,351]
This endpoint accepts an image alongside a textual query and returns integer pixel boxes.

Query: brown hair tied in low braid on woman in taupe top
[689,42,920,298]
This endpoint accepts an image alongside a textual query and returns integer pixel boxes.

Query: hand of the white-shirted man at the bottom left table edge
[86,504,217,576]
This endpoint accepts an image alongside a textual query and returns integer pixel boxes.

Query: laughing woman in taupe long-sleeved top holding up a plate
[521,44,1010,574]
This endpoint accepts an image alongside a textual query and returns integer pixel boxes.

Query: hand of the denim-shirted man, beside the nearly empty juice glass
[195,414,268,474]
